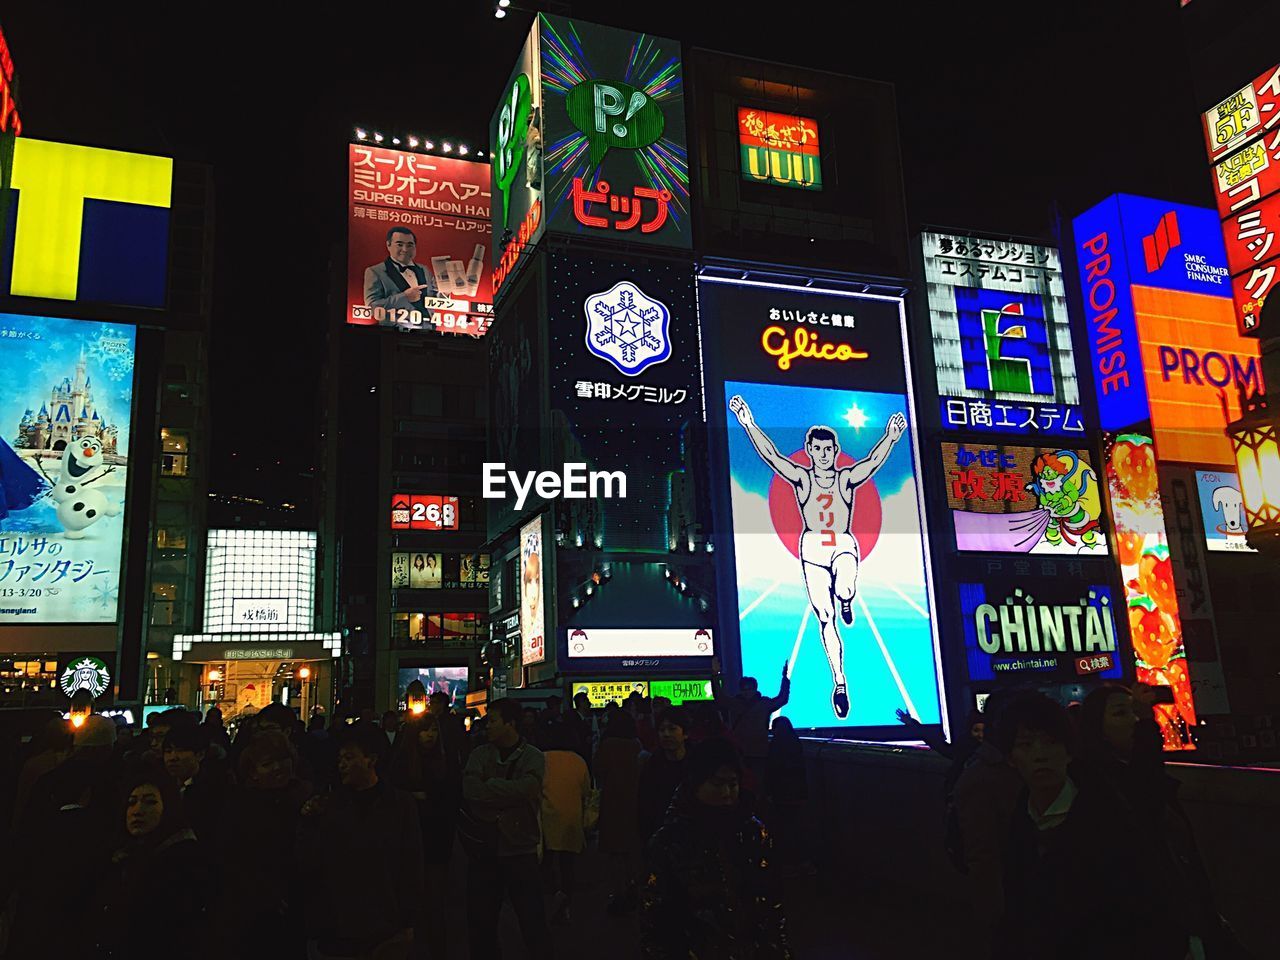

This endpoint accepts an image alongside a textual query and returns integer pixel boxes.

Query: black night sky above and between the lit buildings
[3,0,1212,512]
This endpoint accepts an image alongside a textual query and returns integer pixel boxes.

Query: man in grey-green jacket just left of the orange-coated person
[461,700,552,960]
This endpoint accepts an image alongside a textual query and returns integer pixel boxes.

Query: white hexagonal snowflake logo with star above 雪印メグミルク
[582,280,671,376]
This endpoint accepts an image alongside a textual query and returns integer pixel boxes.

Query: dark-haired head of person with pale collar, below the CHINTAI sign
[993,694,1075,810]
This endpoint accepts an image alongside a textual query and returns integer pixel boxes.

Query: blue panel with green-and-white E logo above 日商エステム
[956,287,1053,396]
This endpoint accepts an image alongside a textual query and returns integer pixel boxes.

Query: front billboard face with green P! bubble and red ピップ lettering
[539,14,691,247]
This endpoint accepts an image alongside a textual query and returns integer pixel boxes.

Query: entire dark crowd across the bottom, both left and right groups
[0,671,1244,960]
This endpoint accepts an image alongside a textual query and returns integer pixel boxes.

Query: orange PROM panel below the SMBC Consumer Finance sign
[1132,284,1262,466]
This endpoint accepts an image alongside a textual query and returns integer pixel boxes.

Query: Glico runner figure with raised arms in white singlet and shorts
[728,396,906,719]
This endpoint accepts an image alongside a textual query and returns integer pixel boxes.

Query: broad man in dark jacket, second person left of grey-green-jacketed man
[298,723,424,957]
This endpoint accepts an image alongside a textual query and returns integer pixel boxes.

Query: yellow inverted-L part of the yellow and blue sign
[9,137,173,300]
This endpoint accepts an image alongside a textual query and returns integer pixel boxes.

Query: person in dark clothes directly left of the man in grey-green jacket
[390,713,462,957]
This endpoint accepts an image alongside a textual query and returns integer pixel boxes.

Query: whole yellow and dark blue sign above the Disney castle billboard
[6,137,173,307]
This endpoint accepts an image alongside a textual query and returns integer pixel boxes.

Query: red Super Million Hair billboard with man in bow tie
[347,143,493,337]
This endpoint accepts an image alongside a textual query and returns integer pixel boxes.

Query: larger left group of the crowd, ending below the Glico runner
[0,675,804,960]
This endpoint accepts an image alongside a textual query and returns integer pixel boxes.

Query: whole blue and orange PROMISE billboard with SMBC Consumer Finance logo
[1074,195,1263,466]
